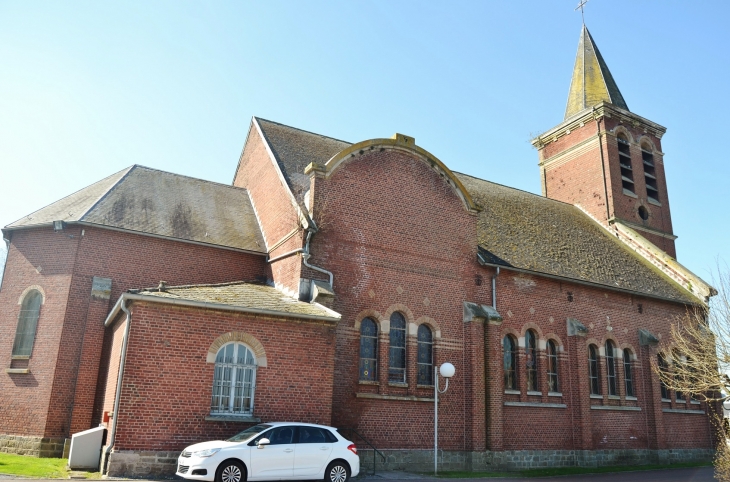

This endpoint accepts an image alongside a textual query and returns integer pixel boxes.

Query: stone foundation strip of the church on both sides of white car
[102,449,715,479]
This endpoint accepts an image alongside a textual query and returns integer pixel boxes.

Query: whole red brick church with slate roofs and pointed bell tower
[0,26,717,477]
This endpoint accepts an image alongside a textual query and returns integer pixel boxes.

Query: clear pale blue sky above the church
[0,0,730,279]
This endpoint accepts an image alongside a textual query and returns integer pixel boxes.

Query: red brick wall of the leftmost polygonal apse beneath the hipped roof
[0,226,265,437]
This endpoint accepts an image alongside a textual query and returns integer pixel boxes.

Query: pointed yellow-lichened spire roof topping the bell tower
[565,25,629,119]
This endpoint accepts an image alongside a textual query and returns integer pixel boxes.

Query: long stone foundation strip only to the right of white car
[358,449,715,472]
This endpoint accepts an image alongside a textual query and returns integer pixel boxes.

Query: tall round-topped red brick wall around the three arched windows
[311,150,485,450]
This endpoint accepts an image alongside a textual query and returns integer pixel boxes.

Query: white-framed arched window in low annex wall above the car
[210,343,256,415]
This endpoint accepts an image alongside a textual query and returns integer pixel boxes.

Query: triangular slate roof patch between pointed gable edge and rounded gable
[254,117,352,202]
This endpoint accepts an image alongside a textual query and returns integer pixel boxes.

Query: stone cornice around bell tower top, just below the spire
[530,102,667,149]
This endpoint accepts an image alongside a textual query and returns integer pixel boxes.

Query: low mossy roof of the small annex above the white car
[130,282,340,320]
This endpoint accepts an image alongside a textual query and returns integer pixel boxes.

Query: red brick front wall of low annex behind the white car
[107,302,335,451]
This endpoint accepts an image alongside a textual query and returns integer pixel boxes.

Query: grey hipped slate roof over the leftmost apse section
[6,165,266,253]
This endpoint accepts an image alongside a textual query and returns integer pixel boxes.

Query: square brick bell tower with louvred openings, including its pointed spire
[532,25,676,258]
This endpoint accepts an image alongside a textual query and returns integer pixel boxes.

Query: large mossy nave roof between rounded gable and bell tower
[456,173,698,304]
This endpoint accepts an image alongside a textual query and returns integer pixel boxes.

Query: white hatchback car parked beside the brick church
[176,422,360,482]
